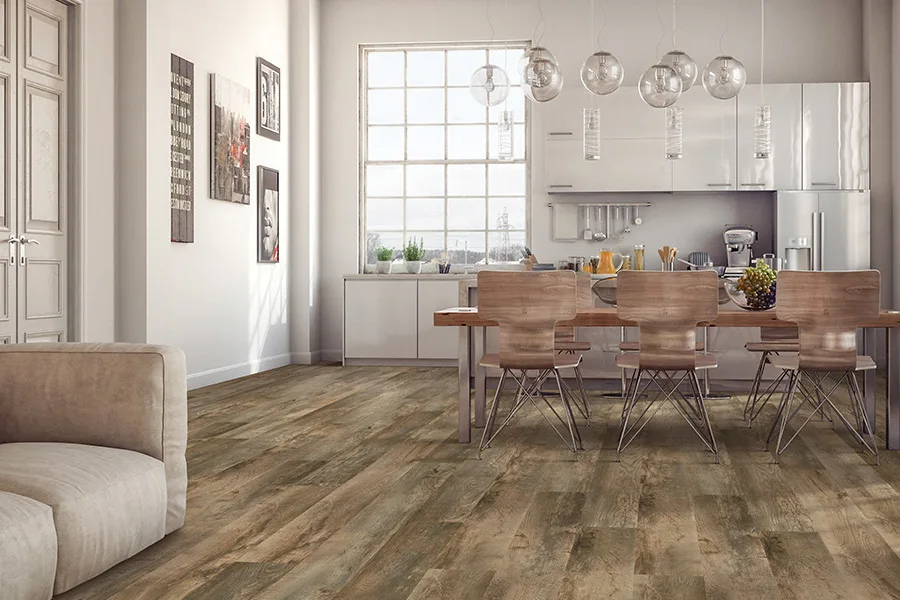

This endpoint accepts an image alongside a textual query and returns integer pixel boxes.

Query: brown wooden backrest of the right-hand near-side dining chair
[775,271,881,371]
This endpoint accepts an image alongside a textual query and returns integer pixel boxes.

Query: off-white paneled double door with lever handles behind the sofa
[0,0,69,344]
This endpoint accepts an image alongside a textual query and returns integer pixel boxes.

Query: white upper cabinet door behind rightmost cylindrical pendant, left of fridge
[737,83,803,190]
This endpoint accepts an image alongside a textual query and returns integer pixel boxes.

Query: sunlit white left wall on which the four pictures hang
[118,0,293,387]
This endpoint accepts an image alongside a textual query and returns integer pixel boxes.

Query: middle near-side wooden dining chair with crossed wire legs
[616,271,719,462]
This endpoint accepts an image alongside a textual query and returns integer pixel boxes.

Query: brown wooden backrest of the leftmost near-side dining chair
[478,271,576,369]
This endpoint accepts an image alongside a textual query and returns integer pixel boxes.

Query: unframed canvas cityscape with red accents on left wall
[209,73,252,204]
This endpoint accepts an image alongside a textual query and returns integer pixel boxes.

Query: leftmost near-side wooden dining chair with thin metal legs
[478,271,581,458]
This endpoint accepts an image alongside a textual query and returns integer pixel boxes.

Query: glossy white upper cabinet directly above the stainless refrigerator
[804,83,869,190]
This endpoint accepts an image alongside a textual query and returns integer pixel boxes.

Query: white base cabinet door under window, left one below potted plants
[344,278,418,358]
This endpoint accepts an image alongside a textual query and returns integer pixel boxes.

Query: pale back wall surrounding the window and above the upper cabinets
[321,0,868,359]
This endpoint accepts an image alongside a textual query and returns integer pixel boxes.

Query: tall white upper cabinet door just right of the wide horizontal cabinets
[672,86,737,192]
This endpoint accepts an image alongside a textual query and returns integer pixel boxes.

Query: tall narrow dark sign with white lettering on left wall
[169,54,194,244]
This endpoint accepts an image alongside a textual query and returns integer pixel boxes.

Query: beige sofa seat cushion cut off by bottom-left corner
[0,492,56,600]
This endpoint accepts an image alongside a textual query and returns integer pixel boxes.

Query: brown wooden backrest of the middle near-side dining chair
[616,271,719,371]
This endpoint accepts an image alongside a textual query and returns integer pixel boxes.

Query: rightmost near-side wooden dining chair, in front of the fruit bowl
[766,270,881,464]
